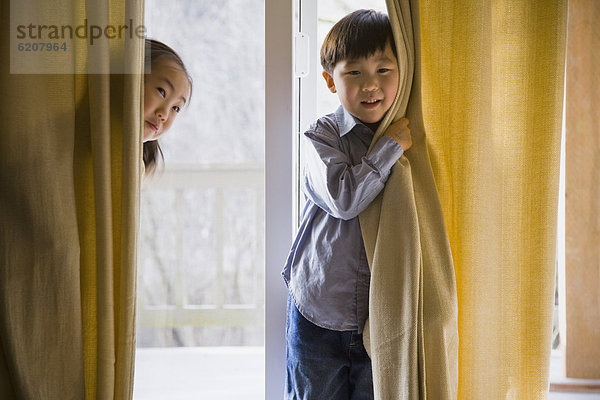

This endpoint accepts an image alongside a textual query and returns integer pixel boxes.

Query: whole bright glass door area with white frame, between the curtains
[134,0,580,400]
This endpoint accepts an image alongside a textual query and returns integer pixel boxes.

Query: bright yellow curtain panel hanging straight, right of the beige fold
[420,0,568,399]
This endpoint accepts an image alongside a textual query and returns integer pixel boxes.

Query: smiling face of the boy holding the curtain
[323,43,398,130]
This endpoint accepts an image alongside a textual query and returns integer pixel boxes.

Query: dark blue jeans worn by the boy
[285,296,373,400]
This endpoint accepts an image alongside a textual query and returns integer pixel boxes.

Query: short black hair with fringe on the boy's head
[321,10,397,74]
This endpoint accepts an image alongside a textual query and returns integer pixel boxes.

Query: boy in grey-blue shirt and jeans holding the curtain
[283,10,412,400]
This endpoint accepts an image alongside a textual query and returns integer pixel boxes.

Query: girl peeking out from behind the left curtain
[143,39,192,176]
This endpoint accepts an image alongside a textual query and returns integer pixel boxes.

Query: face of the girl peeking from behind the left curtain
[143,58,190,142]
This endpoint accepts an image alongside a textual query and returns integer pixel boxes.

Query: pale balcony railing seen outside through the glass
[138,164,264,340]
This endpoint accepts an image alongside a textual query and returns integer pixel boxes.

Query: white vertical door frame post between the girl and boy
[265,0,297,399]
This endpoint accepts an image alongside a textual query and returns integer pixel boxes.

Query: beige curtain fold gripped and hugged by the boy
[360,0,458,400]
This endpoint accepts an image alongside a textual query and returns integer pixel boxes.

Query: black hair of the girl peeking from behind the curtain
[142,38,192,176]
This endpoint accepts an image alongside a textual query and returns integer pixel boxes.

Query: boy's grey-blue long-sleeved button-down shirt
[283,106,402,332]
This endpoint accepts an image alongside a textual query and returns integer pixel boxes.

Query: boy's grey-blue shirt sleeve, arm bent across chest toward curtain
[304,130,403,220]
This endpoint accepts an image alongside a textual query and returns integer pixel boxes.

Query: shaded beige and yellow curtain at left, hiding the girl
[0,0,143,400]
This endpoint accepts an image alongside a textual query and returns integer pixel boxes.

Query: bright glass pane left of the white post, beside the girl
[134,0,265,400]
